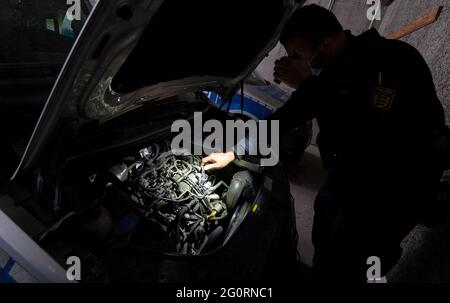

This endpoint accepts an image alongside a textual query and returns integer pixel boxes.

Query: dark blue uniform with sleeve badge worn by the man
[271,30,445,281]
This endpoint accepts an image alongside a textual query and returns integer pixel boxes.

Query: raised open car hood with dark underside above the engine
[13,0,303,178]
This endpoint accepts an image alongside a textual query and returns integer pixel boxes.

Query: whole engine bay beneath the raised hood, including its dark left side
[40,140,257,268]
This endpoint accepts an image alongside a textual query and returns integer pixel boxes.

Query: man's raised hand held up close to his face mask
[273,57,311,89]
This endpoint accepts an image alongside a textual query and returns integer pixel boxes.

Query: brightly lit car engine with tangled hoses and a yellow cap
[106,142,228,255]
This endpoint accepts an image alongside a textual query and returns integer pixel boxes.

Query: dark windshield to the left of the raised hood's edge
[0,0,97,173]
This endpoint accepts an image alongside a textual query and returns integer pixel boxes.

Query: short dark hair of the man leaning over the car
[280,4,343,46]
